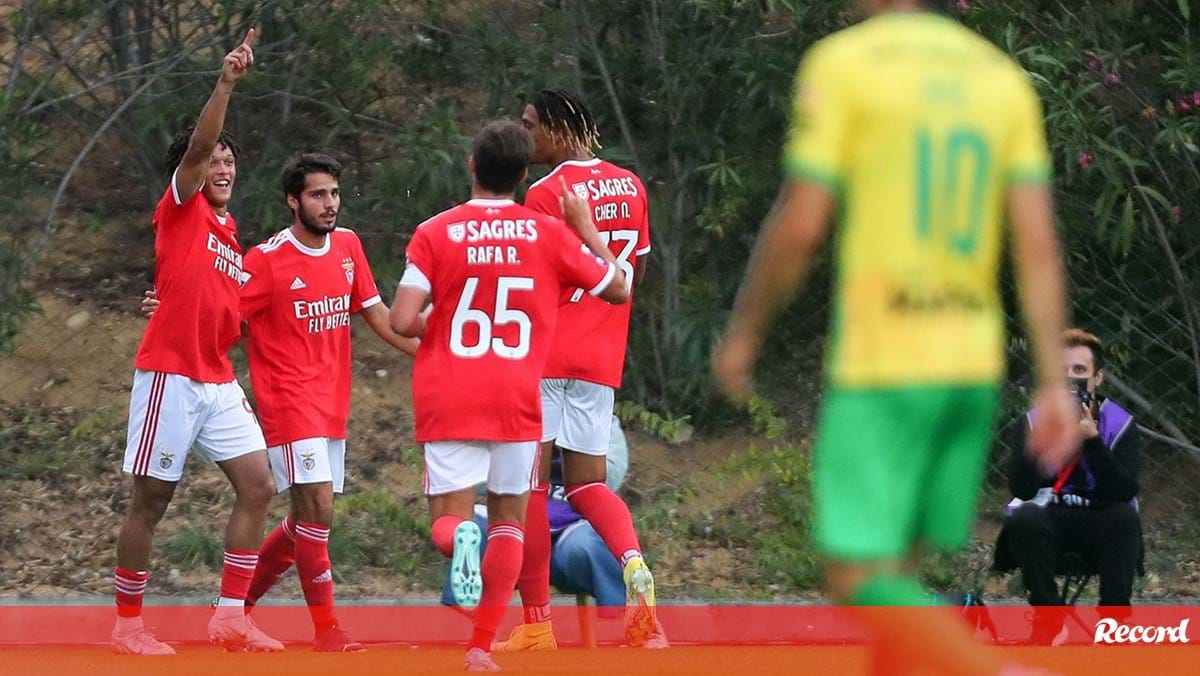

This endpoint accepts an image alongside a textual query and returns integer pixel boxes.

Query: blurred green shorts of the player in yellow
[814,384,998,561]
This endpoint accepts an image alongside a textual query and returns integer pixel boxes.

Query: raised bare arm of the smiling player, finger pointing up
[175,29,254,202]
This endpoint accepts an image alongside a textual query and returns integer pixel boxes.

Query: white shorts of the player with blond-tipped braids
[541,378,613,455]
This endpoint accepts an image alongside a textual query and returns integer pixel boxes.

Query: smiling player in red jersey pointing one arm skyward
[112,30,283,654]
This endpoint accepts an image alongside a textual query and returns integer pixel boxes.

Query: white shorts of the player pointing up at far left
[122,369,266,481]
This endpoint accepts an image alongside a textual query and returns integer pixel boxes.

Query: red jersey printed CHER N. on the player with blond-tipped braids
[526,158,650,388]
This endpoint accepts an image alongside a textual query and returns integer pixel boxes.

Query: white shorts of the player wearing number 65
[424,442,539,495]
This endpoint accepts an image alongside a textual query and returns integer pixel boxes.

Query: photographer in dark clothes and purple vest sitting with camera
[995,329,1141,639]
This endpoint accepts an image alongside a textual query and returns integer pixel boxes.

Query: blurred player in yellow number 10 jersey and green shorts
[713,0,1079,676]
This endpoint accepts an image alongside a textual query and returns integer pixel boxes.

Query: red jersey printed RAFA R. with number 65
[401,199,616,443]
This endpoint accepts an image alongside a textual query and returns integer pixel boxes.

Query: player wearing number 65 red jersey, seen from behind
[391,121,629,671]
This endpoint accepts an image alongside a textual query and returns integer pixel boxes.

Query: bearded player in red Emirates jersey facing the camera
[142,152,418,652]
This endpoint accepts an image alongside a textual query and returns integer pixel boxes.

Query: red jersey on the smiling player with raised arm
[133,177,241,383]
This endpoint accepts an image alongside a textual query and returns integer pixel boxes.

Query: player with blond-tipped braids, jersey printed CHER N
[496,90,667,651]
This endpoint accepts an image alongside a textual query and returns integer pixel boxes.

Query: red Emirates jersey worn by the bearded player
[237,228,379,445]
